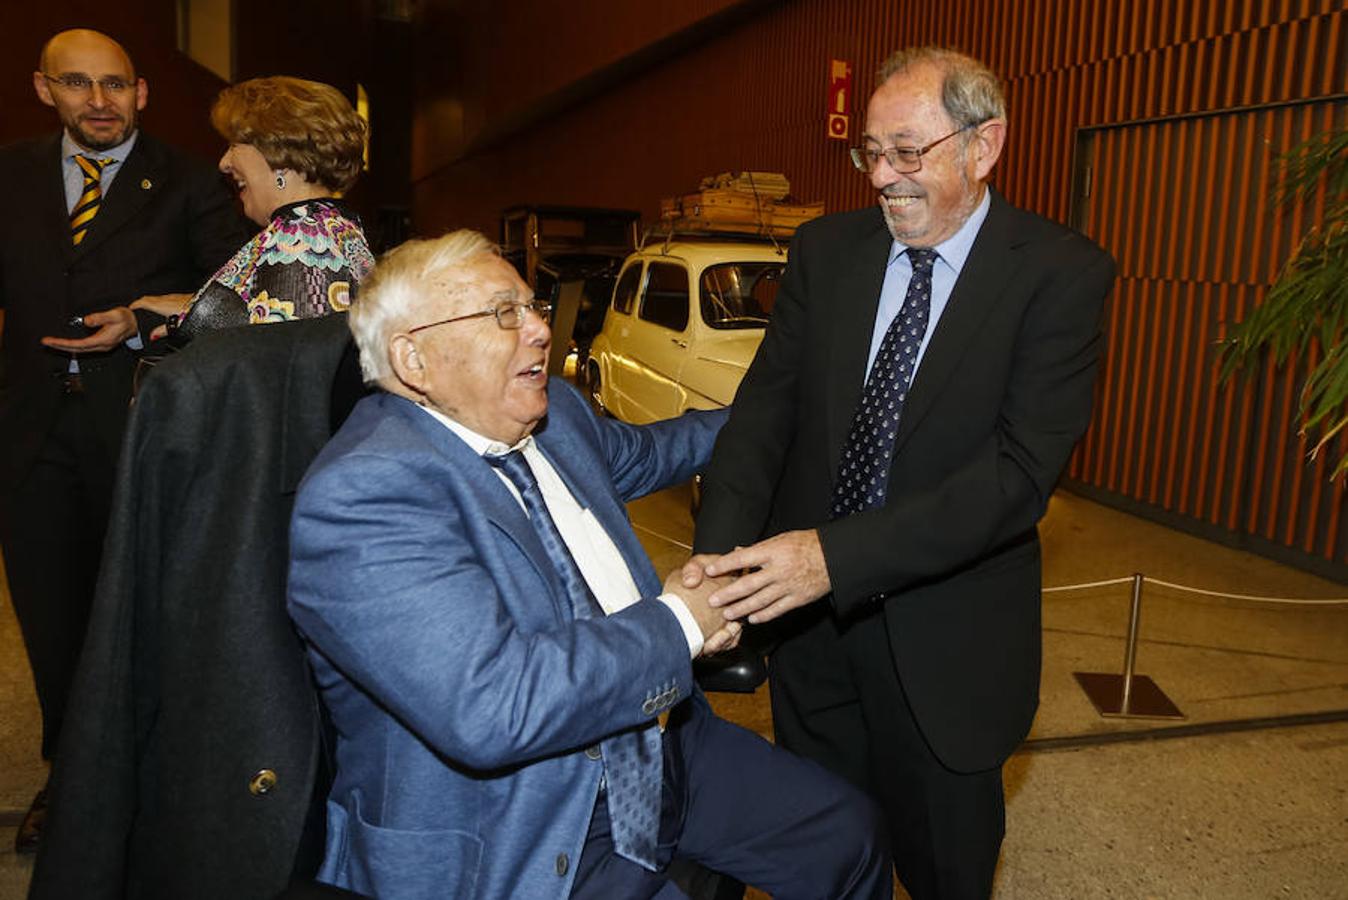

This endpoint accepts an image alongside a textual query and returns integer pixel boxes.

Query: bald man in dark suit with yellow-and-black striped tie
[0,30,248,850]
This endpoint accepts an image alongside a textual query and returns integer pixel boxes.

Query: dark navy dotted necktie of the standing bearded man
[832,247,937,519]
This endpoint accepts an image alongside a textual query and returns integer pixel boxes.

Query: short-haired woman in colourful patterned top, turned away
[133,75,375,327]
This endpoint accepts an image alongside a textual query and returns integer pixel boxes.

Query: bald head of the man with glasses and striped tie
[32,28,150,151]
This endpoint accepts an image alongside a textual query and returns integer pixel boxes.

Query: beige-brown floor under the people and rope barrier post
[0,489,1348,900]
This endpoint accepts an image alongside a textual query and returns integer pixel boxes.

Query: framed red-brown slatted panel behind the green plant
[1069,98,1348,563]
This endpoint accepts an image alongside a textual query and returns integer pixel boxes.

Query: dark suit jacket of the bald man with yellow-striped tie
[0,132,249,485]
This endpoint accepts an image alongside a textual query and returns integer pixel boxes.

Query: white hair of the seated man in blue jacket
[348,228,500,384]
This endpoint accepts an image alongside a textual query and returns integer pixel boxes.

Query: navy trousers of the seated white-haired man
[572,699,892,900]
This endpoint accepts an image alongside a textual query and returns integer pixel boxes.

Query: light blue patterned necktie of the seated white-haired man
[485,450,665,872]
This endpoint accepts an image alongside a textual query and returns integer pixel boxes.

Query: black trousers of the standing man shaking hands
[768,605,1006,900]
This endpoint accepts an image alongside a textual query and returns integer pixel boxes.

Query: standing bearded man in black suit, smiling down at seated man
[685,49,1113,899]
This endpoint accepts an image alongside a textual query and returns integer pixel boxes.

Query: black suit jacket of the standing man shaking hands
[696,193,1113,771]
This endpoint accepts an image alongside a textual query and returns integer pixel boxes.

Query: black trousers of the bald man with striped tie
[0,392,117,759]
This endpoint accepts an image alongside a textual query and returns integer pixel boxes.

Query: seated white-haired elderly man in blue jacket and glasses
[290,232,891,900]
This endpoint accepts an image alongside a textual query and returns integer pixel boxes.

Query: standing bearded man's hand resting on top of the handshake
[706,529,832,625]
